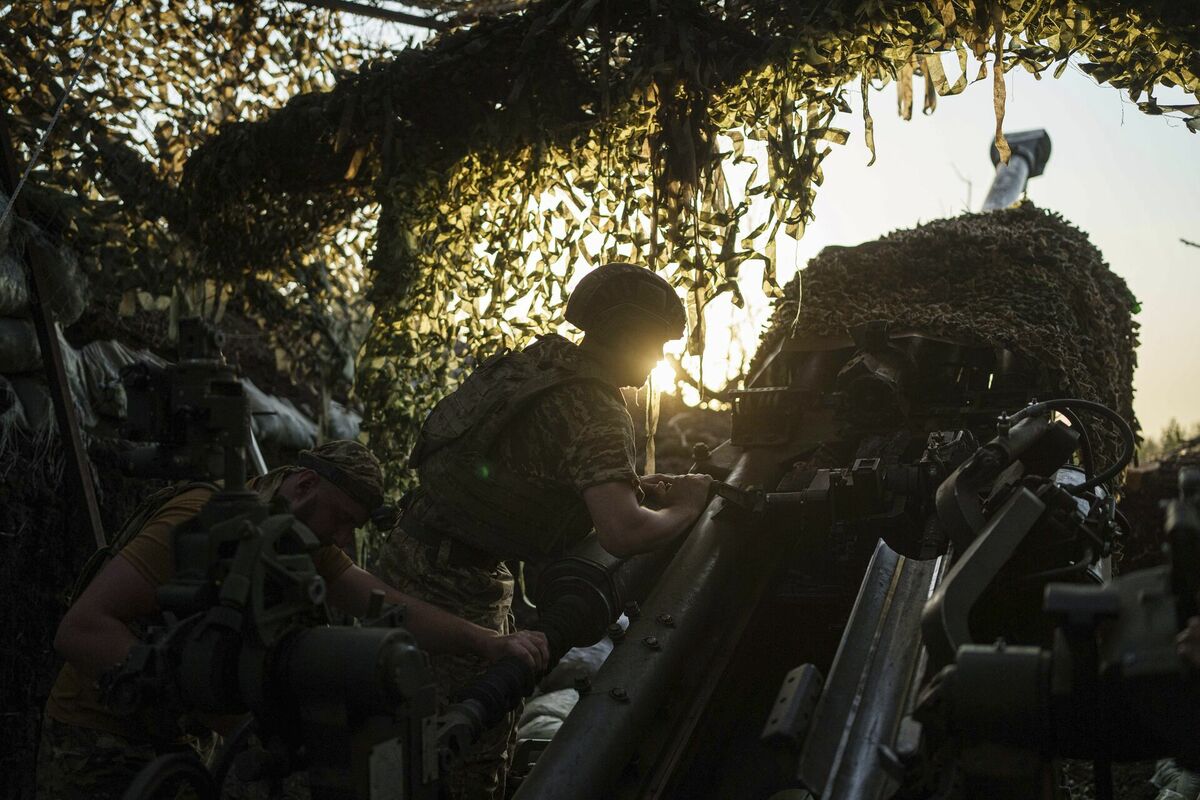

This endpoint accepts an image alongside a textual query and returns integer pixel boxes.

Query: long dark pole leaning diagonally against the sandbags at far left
[0,104,106,547]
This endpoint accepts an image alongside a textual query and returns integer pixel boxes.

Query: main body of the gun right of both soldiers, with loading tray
[516,132,1194,800]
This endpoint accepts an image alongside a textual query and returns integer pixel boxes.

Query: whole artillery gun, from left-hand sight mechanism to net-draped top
[105,133,1200,800]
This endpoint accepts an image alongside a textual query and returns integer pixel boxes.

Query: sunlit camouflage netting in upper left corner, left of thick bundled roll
[0,0,378,393]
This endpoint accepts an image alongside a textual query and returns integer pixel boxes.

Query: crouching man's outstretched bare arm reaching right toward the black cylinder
[329,566,550,672]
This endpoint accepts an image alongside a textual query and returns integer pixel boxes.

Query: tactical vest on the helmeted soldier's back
[401,336,624,561]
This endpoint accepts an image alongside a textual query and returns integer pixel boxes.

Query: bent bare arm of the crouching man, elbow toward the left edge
[54,557,158,678]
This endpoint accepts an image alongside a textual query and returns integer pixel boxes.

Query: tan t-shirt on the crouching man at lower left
[46,488,354,739]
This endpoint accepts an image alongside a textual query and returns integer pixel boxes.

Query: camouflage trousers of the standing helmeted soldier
[379,529,520,800]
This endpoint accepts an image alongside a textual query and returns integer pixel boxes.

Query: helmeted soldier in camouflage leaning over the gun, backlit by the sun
[380,264,712,800]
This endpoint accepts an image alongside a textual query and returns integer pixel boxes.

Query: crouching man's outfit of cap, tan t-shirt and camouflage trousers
[37,441,383,800]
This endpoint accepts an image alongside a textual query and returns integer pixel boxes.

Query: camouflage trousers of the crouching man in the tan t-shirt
[37,716,212,800]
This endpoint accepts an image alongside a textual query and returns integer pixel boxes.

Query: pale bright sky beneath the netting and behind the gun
[360,20,1200,437]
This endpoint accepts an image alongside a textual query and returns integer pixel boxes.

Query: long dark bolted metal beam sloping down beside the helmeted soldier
[516,452,776,800]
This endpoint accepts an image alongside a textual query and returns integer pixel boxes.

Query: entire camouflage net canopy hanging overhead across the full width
[0,0,1200,491]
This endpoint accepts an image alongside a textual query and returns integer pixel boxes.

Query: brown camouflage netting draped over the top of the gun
[750,203,1138,464]
